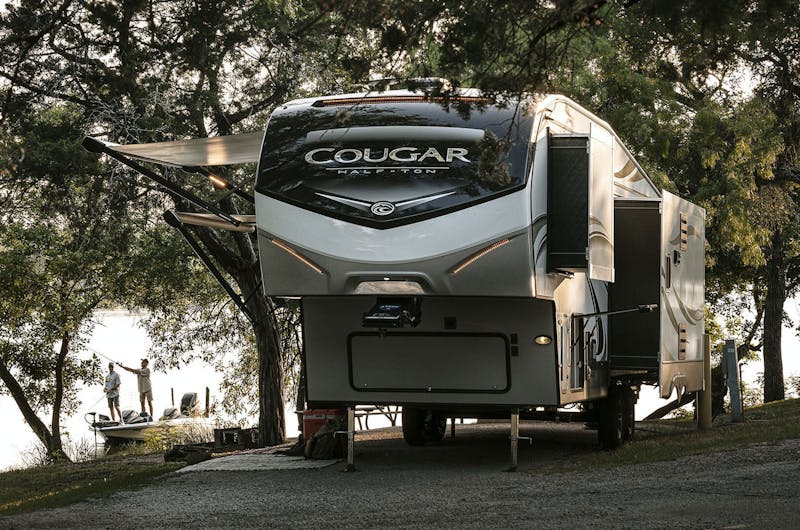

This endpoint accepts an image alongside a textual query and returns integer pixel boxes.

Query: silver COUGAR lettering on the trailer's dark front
[305,147,470,164]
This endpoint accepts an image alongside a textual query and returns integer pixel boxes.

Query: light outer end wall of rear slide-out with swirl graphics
[659,191,706,398]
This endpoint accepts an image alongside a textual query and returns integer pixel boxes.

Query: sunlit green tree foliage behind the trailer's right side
[552,0,800,374]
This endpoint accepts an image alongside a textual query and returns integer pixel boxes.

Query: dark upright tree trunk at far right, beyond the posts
[764,230,786,403]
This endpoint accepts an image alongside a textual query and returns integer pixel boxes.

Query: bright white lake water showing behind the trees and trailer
[0,308,800,470]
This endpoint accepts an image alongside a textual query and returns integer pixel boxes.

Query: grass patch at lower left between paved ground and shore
[0,457,184,516]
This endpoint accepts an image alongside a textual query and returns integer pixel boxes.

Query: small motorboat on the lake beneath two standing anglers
[85,392,214,446]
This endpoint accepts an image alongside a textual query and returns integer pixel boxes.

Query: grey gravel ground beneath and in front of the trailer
[0,424,800,529]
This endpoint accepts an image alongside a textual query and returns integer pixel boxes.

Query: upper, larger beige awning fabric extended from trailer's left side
[103,132,264,167]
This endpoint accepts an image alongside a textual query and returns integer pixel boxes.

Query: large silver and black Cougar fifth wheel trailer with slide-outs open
[83,90,705,460]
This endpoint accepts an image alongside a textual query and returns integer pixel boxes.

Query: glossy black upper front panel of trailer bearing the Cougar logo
[256,102,531,228]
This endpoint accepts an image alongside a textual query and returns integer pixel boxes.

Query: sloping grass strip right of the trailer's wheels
[574,399,800,469]
